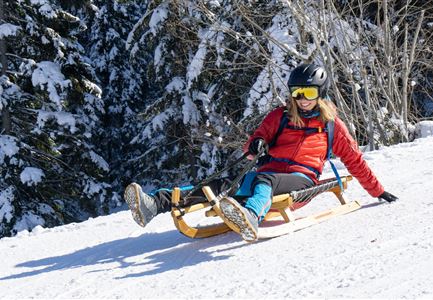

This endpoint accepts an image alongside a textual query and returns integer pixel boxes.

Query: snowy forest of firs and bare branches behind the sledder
[0,0,433,237]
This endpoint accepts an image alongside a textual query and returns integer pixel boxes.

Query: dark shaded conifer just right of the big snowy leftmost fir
[70,0,150,211]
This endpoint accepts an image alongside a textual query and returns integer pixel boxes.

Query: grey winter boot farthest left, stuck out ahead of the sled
[124,183,158,227]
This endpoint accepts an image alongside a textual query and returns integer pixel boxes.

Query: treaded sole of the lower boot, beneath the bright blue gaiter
[219,198,257,242]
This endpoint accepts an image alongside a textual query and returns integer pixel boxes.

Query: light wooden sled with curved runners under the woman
[171,176,361,239]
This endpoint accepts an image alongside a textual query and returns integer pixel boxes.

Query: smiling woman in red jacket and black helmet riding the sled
[125,64,397,242]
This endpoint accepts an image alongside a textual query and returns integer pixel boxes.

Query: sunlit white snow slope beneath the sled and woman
[0,137,433,299]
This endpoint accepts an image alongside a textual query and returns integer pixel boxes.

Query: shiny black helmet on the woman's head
[287,64,328,98]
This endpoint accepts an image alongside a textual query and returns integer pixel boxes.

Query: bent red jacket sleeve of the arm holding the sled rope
[243,107,284,153]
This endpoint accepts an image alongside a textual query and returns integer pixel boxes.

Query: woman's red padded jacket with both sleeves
[244,107,384,197]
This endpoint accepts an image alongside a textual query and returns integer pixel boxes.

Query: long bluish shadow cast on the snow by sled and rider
[0,230,247,280]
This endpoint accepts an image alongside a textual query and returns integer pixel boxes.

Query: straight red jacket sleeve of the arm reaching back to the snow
[332,118,384,197]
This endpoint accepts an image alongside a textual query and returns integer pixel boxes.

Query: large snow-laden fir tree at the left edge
[0,0,110,236]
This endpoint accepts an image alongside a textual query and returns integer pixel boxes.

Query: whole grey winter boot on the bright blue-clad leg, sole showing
[219,197,259,242]
